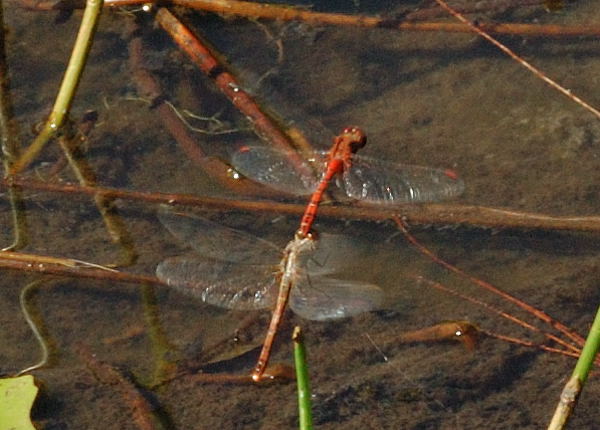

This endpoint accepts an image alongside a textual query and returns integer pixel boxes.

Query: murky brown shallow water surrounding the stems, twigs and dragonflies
[0,2,600,429]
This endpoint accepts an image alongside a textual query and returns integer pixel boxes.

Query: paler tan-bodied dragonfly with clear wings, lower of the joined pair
[156,209,383,381]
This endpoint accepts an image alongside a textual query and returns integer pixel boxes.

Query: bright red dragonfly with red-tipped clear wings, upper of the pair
[231,127,464,234]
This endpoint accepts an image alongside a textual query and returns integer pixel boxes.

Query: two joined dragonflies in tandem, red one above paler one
[156,127,464,380]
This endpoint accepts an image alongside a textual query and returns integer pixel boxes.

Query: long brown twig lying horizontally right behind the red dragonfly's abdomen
[5,177,600,232]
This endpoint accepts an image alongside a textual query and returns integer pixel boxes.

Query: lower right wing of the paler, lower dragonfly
[290,277,383,321]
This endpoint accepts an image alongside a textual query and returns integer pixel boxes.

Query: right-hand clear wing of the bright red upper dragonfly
[340,156,465,204]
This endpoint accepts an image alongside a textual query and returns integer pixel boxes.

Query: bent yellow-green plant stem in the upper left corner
[11,0,104,174]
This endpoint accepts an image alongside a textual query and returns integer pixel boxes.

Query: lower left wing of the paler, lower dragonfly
[156,256,277,310]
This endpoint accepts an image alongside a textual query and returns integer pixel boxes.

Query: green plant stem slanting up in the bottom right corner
[548,307,600,430]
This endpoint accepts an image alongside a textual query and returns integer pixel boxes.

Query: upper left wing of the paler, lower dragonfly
[158,206,281,264]
